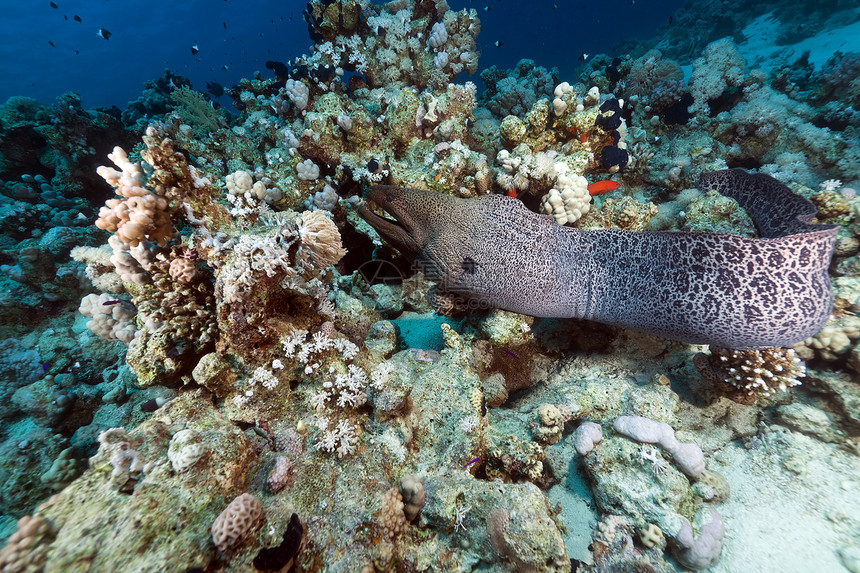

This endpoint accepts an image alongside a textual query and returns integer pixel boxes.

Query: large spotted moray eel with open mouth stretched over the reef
[359,169,837,349]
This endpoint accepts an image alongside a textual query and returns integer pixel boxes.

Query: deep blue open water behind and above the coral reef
[0,0,683,108]
